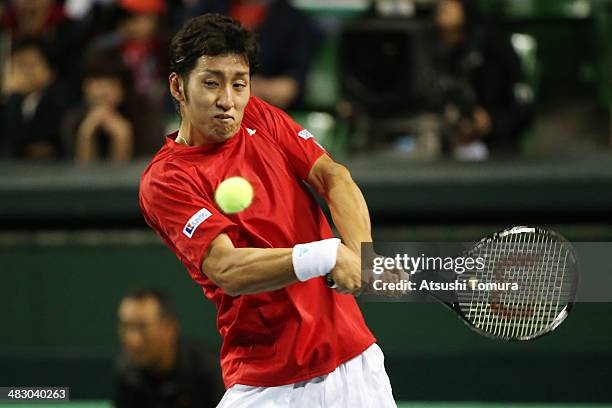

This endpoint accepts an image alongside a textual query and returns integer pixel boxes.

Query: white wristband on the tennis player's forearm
[292,238,340,282]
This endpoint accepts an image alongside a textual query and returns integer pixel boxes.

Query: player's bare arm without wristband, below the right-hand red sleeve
[308,154,372,255]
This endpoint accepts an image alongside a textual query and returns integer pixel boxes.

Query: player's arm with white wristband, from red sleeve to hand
[140,166,361,296]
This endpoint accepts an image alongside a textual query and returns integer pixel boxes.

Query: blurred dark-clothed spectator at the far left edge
[0,39,66,160]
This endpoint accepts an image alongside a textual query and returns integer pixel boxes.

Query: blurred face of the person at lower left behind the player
[119,298,177,368]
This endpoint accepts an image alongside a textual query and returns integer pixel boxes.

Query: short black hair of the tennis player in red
[170,14,258,101]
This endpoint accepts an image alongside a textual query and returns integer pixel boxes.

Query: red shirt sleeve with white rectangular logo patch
[140,166,238,279]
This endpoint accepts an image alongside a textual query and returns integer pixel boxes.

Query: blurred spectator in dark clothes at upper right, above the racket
[435,0,532,160]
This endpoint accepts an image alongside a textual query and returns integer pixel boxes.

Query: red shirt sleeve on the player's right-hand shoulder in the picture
[258,101,327,180]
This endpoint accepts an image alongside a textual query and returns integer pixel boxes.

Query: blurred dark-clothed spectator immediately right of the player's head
[198,0,320,109]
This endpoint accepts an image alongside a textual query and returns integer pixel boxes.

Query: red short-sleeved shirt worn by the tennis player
[140,97,375,388]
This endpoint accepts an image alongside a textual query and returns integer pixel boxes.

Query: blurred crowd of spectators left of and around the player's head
[0,0,319,162]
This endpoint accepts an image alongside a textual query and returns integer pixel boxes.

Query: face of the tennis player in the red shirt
[175,54,251,144]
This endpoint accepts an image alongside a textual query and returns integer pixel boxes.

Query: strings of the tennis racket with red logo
[457,233,574,339]
